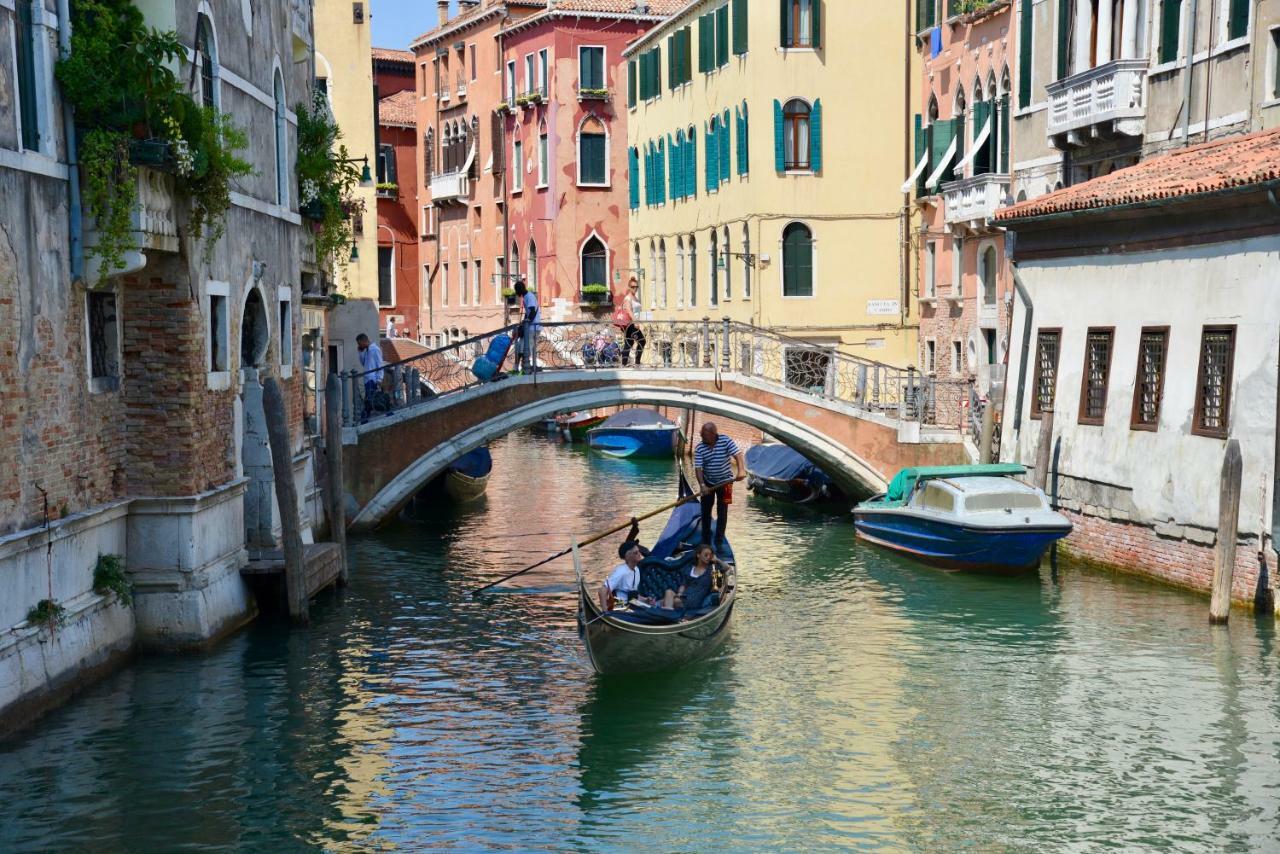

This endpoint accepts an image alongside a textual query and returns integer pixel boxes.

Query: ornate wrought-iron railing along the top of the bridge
[342,319,954,426]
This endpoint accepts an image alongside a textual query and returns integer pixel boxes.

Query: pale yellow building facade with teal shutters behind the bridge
[624,0,916,365]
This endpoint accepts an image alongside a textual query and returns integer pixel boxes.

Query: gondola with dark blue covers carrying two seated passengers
[573,503,737,675]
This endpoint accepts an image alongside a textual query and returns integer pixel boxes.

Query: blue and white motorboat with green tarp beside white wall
[854,465,1071,572]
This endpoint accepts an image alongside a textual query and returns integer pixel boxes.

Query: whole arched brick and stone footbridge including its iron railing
[343,320,969,530]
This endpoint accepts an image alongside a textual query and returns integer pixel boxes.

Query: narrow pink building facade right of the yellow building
[915,0,1016,425]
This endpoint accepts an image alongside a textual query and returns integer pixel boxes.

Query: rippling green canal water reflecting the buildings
[0,433,1280,851]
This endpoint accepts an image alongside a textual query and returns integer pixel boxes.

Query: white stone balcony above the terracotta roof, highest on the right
[1046,59,1147,151]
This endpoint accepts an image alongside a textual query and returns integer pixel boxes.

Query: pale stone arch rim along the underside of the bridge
[351,383,886,531]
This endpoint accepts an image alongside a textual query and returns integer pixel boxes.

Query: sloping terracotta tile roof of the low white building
[995,128,1280,222]
